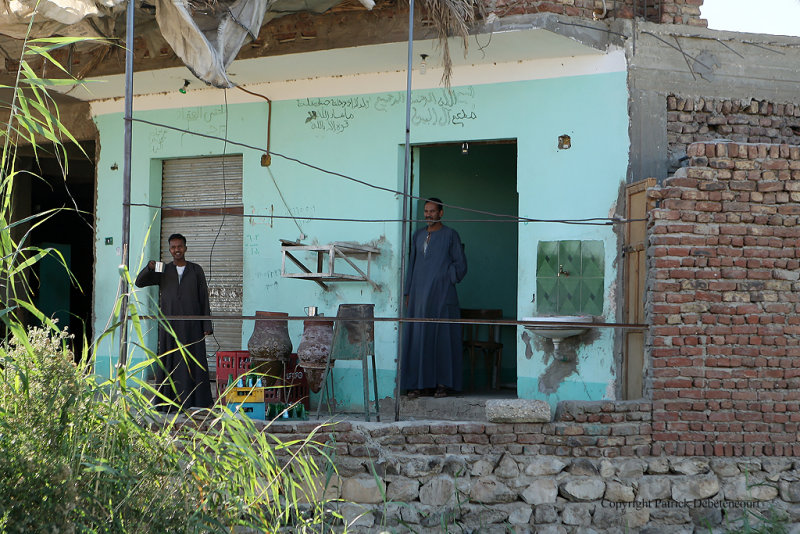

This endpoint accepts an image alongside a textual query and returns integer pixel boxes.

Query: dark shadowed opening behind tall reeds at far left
[14,142,95,357]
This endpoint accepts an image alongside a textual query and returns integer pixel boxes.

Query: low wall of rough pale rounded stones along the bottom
[269,420,800,534]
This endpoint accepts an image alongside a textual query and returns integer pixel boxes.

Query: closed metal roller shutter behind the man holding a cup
[161,155,243,376]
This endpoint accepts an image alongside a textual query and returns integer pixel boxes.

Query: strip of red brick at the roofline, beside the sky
[485,0,708,26]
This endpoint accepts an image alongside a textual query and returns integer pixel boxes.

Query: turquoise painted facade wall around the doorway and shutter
[95,72,628,410]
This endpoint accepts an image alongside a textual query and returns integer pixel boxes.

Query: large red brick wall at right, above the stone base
[646,142,800,456]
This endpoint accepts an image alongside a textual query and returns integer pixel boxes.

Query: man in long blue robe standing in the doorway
[401,198,467,398]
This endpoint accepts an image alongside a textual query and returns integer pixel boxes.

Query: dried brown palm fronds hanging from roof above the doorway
[422,0,484,89]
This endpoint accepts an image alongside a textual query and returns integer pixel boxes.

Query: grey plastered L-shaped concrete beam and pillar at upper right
[628,20,800,182]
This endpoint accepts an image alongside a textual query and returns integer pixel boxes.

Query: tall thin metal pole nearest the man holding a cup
[118,0,134,366]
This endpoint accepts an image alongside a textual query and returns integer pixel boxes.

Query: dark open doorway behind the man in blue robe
[412,141,519,394]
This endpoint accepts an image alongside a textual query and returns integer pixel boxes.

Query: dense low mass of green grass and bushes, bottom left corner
[0,328,346,533]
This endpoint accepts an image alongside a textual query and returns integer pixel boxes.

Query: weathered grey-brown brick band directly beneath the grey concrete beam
[667,95,800,171]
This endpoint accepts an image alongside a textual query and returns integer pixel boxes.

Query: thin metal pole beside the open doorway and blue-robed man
[394,0,414,421]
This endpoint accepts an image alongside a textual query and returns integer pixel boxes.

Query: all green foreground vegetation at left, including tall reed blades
[0,23,346,533]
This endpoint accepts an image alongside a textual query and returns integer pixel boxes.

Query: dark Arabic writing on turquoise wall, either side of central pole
[296,87,478,133]
